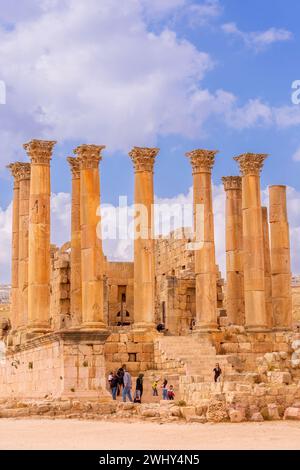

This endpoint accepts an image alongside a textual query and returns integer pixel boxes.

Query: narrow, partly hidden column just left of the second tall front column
[67,157,82,326]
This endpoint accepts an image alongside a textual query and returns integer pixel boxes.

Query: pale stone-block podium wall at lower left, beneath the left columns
[0,332,105,399]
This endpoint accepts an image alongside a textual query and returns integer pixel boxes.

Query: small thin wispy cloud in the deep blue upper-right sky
[222,23,293,51]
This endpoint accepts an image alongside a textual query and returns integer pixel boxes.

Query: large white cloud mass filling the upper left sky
[0,0,219,166]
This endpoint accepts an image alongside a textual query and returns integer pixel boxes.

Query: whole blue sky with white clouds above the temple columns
[0,0,300,280]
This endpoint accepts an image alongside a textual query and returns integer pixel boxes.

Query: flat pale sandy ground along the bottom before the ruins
[0,419,300,450]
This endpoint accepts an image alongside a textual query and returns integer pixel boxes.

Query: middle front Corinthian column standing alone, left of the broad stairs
[129,147,159,329]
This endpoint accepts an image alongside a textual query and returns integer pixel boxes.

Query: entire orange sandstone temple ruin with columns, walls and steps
[0,140,300,422]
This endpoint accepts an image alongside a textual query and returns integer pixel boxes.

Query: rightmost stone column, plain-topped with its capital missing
[269,186,292,329]
